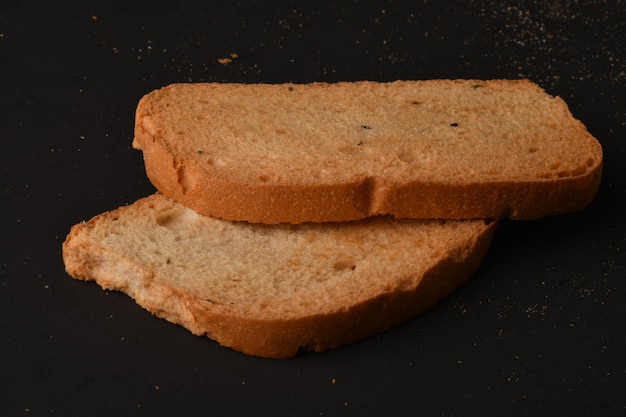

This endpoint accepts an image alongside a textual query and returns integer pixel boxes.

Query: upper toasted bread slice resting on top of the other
[134,80,602,223]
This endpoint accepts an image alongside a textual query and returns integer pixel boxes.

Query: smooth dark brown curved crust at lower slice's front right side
[195,223,496,358]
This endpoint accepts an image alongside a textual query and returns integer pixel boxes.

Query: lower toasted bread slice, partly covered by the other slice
[63,193,497,358]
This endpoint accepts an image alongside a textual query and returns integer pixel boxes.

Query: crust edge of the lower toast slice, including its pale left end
[63,194,497,358]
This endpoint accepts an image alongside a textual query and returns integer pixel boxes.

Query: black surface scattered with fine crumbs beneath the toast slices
[0,0,626,416]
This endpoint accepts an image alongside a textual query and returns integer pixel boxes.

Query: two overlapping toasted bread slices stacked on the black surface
[63,80,602,358]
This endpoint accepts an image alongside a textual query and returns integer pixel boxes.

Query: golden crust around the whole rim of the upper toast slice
[134,80,602,224]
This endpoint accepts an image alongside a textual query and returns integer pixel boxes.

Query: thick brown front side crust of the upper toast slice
[136,126,602,224]
